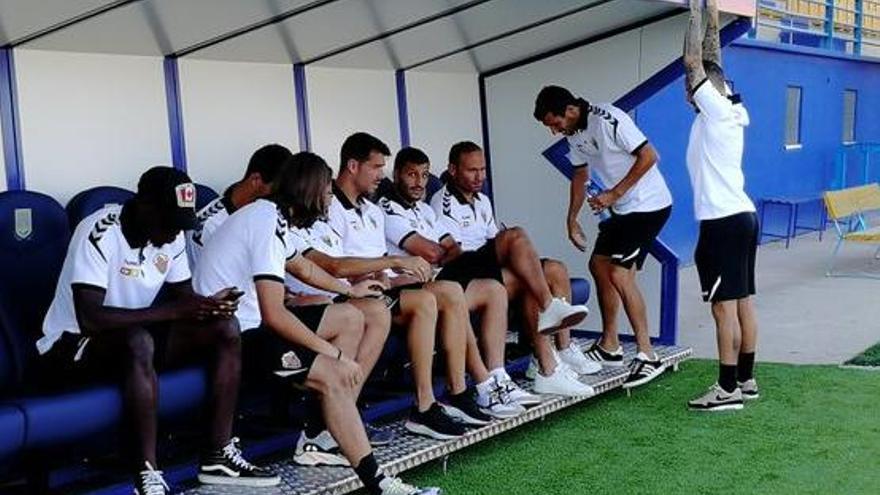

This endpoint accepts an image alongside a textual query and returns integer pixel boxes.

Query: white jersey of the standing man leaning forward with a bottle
[568,104,672,215]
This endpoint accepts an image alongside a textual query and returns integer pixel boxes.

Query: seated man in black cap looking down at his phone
[37,167,280,495]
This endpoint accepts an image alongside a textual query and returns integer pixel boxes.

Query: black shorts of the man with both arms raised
[694,212,758,302]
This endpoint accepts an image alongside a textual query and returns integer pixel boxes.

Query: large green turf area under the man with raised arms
[405,361,880,495]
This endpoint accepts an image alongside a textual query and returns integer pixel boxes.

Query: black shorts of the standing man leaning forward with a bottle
[593,206,672,270]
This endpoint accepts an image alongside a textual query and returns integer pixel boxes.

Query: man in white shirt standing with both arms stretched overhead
[684,0,758,411]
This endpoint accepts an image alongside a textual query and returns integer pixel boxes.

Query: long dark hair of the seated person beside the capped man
[274,151,333,228]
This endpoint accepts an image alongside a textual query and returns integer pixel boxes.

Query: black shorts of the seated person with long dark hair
[241,304,330,383]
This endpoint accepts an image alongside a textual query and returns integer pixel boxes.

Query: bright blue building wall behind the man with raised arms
[637,40,880,263]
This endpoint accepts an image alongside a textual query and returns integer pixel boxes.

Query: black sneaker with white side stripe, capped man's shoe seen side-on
[199,438,281,487]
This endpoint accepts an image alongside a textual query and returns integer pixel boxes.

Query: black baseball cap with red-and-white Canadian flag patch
[137,166,198,230]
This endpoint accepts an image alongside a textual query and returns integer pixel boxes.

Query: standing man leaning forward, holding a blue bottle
[534,86,672,388]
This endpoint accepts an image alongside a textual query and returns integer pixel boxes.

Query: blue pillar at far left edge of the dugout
[0,48,24,191]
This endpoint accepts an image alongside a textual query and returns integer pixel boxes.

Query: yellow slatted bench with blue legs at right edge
[824,183,880,278]
